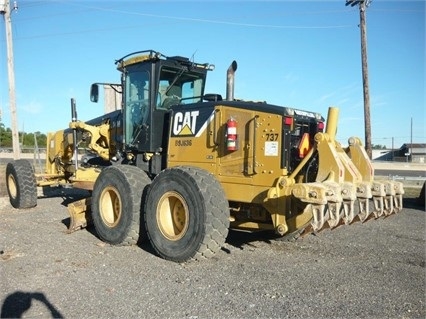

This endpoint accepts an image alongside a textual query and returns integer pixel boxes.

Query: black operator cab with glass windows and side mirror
[91,50,214,166]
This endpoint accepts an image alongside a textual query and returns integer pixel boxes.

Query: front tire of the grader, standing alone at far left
[6,159,37,208]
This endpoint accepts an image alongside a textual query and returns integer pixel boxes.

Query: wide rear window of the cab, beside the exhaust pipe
[157,66,205,109]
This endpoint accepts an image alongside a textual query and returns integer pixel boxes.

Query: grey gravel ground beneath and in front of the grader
[0,189,426,319]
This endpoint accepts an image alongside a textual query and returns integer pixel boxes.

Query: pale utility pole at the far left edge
[0,0,20,159]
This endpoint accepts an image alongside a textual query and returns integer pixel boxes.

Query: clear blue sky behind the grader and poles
[0,0,426,148]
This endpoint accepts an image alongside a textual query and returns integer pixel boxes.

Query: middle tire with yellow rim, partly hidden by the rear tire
[92,165,151,246]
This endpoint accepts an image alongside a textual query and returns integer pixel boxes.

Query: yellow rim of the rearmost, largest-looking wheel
[157,192,189,241]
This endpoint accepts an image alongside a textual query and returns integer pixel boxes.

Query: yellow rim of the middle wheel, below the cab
[99,186,122,228]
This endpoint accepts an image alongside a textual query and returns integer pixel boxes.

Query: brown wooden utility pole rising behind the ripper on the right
[346,0,373,159]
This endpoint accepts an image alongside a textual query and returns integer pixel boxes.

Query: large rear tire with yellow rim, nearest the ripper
[144,167,229,262]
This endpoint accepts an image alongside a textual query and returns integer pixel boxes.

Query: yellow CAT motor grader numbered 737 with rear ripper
[6,50,404,262]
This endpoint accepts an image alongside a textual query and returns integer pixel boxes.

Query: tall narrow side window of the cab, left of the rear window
[125,71,150,144]
